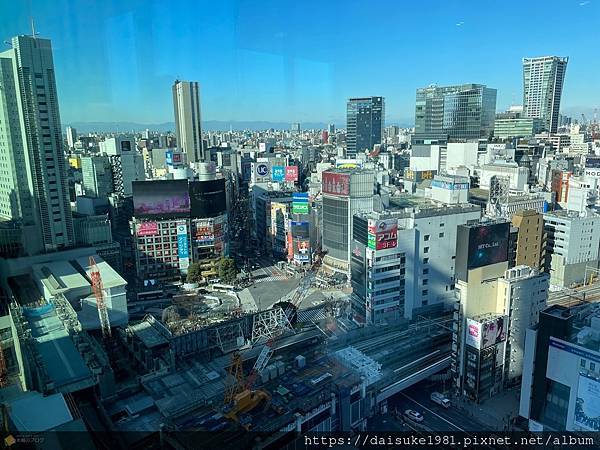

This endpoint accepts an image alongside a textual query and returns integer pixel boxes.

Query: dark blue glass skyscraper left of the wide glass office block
[346,97,385,158]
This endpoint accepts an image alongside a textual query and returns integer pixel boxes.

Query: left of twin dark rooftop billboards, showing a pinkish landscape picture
[133,180,190,217]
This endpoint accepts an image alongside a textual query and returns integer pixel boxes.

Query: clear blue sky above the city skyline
[0,0,600,123]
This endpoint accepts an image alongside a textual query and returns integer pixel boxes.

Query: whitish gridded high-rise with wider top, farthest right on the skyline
[523,56,569,133]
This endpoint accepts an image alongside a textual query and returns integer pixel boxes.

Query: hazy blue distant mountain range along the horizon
[63,119,413,134]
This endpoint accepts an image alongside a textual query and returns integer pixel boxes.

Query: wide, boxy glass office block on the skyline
[415,84,496,140]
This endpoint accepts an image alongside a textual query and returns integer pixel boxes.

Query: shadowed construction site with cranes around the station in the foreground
[0,250,451,448]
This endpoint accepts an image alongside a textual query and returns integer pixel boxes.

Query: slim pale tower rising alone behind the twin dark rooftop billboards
[173,80,205,163]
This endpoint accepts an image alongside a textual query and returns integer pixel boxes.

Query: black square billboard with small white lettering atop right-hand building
[467,222,510,270]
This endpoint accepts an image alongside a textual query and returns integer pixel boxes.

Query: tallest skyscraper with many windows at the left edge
[0,36,74,251]
